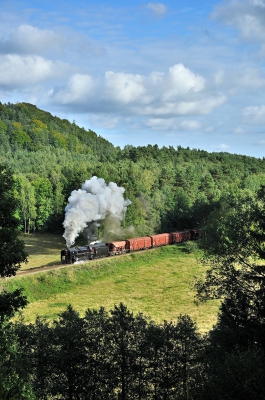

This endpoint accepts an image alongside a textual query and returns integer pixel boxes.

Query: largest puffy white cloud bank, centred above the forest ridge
[50,64,225,119]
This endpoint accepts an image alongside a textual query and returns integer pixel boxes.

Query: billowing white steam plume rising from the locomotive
[63,176,131,247]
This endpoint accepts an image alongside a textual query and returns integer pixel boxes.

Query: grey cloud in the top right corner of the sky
[212,0,265,41]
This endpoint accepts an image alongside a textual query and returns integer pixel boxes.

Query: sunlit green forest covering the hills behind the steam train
[0,103,265,235]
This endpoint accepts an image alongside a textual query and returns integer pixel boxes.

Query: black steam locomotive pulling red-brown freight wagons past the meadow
[61,229,201,264]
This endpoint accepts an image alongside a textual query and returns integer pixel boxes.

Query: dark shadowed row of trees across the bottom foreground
[3,304,265,400]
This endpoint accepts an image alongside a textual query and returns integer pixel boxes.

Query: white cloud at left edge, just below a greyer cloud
[0,54,71,89]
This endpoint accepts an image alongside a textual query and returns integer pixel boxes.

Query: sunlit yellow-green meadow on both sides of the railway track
[4,235,218,332]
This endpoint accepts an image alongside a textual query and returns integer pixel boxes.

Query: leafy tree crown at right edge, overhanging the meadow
[197,187,265,299]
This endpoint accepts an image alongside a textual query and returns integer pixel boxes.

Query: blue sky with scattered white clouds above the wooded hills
[0,0,265,157]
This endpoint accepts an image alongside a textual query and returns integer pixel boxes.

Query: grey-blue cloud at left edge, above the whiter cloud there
[0,25,66,55]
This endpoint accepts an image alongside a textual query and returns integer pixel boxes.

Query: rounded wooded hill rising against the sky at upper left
[0,103,114,159]
